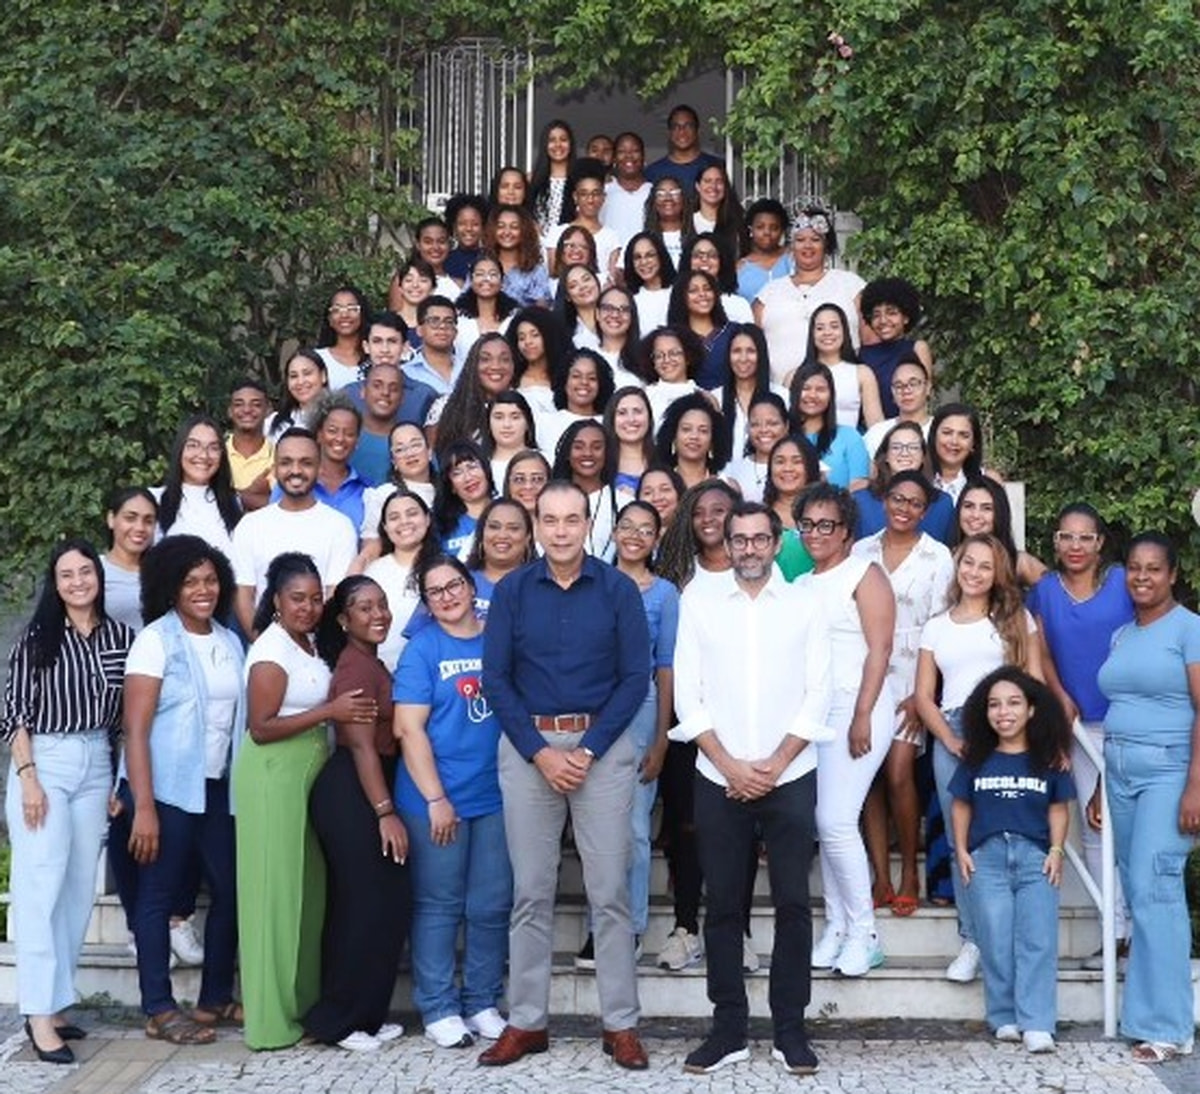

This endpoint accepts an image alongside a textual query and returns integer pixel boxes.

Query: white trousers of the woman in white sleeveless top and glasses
[817,684,894,936]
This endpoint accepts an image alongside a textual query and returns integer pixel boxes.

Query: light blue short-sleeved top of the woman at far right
[1097,605,1200,746]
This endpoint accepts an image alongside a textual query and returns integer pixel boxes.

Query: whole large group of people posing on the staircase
[2,107,1200,1074]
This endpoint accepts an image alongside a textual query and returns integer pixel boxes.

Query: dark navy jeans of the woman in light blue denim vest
[131,779,238,1016]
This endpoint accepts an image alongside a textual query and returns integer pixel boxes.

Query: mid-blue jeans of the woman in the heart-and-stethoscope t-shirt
[404,812,512,1026]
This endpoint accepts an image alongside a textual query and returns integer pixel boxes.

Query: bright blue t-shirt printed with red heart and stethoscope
[391,625,500,819]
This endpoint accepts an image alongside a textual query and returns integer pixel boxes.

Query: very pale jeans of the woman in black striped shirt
[5,729,113,1015]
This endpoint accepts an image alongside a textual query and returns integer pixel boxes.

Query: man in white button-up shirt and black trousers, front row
[671,501,833,1075]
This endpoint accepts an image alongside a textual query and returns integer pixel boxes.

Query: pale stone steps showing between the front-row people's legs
[0,849,1180,1022]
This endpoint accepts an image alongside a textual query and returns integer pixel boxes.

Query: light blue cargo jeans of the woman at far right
[1104,737,1193,1044]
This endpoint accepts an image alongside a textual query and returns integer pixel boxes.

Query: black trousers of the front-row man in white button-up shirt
[695,771,817,1040]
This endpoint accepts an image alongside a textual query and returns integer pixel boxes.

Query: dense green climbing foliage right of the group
[472,0,1200,585]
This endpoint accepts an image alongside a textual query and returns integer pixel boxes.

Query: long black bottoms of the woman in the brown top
[302,749,413,1045]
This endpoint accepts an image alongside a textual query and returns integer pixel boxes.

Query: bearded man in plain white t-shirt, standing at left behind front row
[232,428,359,638]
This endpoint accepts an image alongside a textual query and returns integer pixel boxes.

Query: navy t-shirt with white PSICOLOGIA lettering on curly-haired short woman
[950,752,1075,850]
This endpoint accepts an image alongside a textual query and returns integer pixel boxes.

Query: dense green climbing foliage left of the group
[0,0,463,594]
